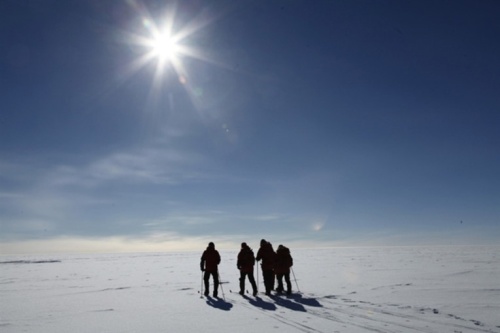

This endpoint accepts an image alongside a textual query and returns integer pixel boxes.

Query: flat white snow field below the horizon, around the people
[0,247,500,333]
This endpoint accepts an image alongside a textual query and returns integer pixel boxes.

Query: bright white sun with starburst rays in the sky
[120,1,219,110]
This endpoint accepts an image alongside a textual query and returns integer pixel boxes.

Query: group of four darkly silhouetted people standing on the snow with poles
[200,239,293,297]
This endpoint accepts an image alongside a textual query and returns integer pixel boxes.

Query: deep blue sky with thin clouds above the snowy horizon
[0,0,500,253]
